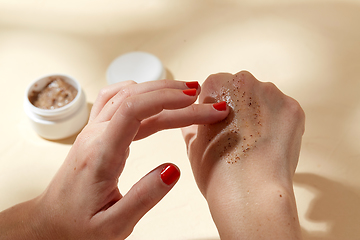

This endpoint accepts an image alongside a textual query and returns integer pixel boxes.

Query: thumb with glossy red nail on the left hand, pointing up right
[112,163,180,229]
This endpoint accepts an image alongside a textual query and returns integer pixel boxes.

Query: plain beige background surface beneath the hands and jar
[0,0,360,240]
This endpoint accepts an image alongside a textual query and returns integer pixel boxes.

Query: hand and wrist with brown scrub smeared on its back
[183,71,305,240]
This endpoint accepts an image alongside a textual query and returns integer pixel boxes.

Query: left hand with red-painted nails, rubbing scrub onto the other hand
[0,80,229,239]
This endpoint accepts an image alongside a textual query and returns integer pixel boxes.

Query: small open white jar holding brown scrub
[24,74,89,140]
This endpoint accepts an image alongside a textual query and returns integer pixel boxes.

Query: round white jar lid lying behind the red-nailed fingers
[106,52,165,84]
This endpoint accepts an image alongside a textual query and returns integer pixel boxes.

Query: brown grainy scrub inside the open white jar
[29,77,78,109]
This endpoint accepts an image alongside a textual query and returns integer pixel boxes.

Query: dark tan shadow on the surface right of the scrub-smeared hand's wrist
[294,173,360,240]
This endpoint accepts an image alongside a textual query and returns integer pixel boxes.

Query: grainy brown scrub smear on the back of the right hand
[198,73,262,164]
